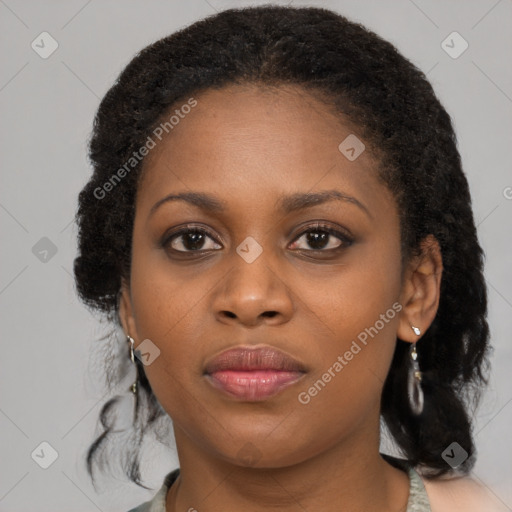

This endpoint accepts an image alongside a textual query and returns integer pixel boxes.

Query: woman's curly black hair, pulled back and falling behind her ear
[74,5,491,487]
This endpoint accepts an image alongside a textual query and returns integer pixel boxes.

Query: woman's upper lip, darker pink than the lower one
[204,346,306,374]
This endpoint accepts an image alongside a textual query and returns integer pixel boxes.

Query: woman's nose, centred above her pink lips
[213,251,294,327]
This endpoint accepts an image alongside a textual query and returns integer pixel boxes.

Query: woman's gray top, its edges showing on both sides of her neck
[128,459,432,512]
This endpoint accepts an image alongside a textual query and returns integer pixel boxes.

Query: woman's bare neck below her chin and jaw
[166,418,409,512]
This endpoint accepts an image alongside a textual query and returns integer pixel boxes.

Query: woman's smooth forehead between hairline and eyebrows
[138,84,383,218]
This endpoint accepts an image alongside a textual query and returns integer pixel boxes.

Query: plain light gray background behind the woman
[0,0,512,512]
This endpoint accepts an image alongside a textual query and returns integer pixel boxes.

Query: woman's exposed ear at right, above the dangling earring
[397,235,443,343]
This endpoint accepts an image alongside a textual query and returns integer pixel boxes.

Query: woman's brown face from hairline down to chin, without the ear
[121,86,414,467]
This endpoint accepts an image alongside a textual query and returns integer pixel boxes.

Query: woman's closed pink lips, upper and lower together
[205,347,305,401]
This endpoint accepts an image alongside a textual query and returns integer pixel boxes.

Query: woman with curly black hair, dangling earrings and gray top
[75,6,508,512]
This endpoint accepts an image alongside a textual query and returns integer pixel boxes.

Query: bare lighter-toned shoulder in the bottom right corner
[422,476,511,512]
